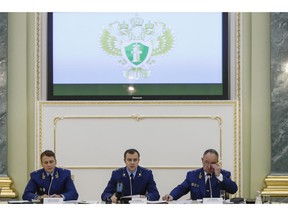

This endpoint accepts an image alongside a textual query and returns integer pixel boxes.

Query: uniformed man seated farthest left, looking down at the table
[22,150,78,201]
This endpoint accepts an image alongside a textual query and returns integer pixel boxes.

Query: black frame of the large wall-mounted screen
[47,12,230,101]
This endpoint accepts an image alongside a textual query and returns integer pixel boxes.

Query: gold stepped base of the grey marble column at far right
[261,176,288,197]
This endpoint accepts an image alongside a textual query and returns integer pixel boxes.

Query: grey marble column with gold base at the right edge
[262,13,288,200]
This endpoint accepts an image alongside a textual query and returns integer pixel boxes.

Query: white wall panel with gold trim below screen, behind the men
[36,101,241,200]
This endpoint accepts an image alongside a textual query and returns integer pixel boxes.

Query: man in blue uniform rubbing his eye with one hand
[162,149,238,201]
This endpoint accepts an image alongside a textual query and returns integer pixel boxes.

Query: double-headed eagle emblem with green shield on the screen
[100,15,175,80]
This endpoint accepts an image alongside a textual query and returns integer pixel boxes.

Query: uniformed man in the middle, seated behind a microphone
[101,149,160,203]
